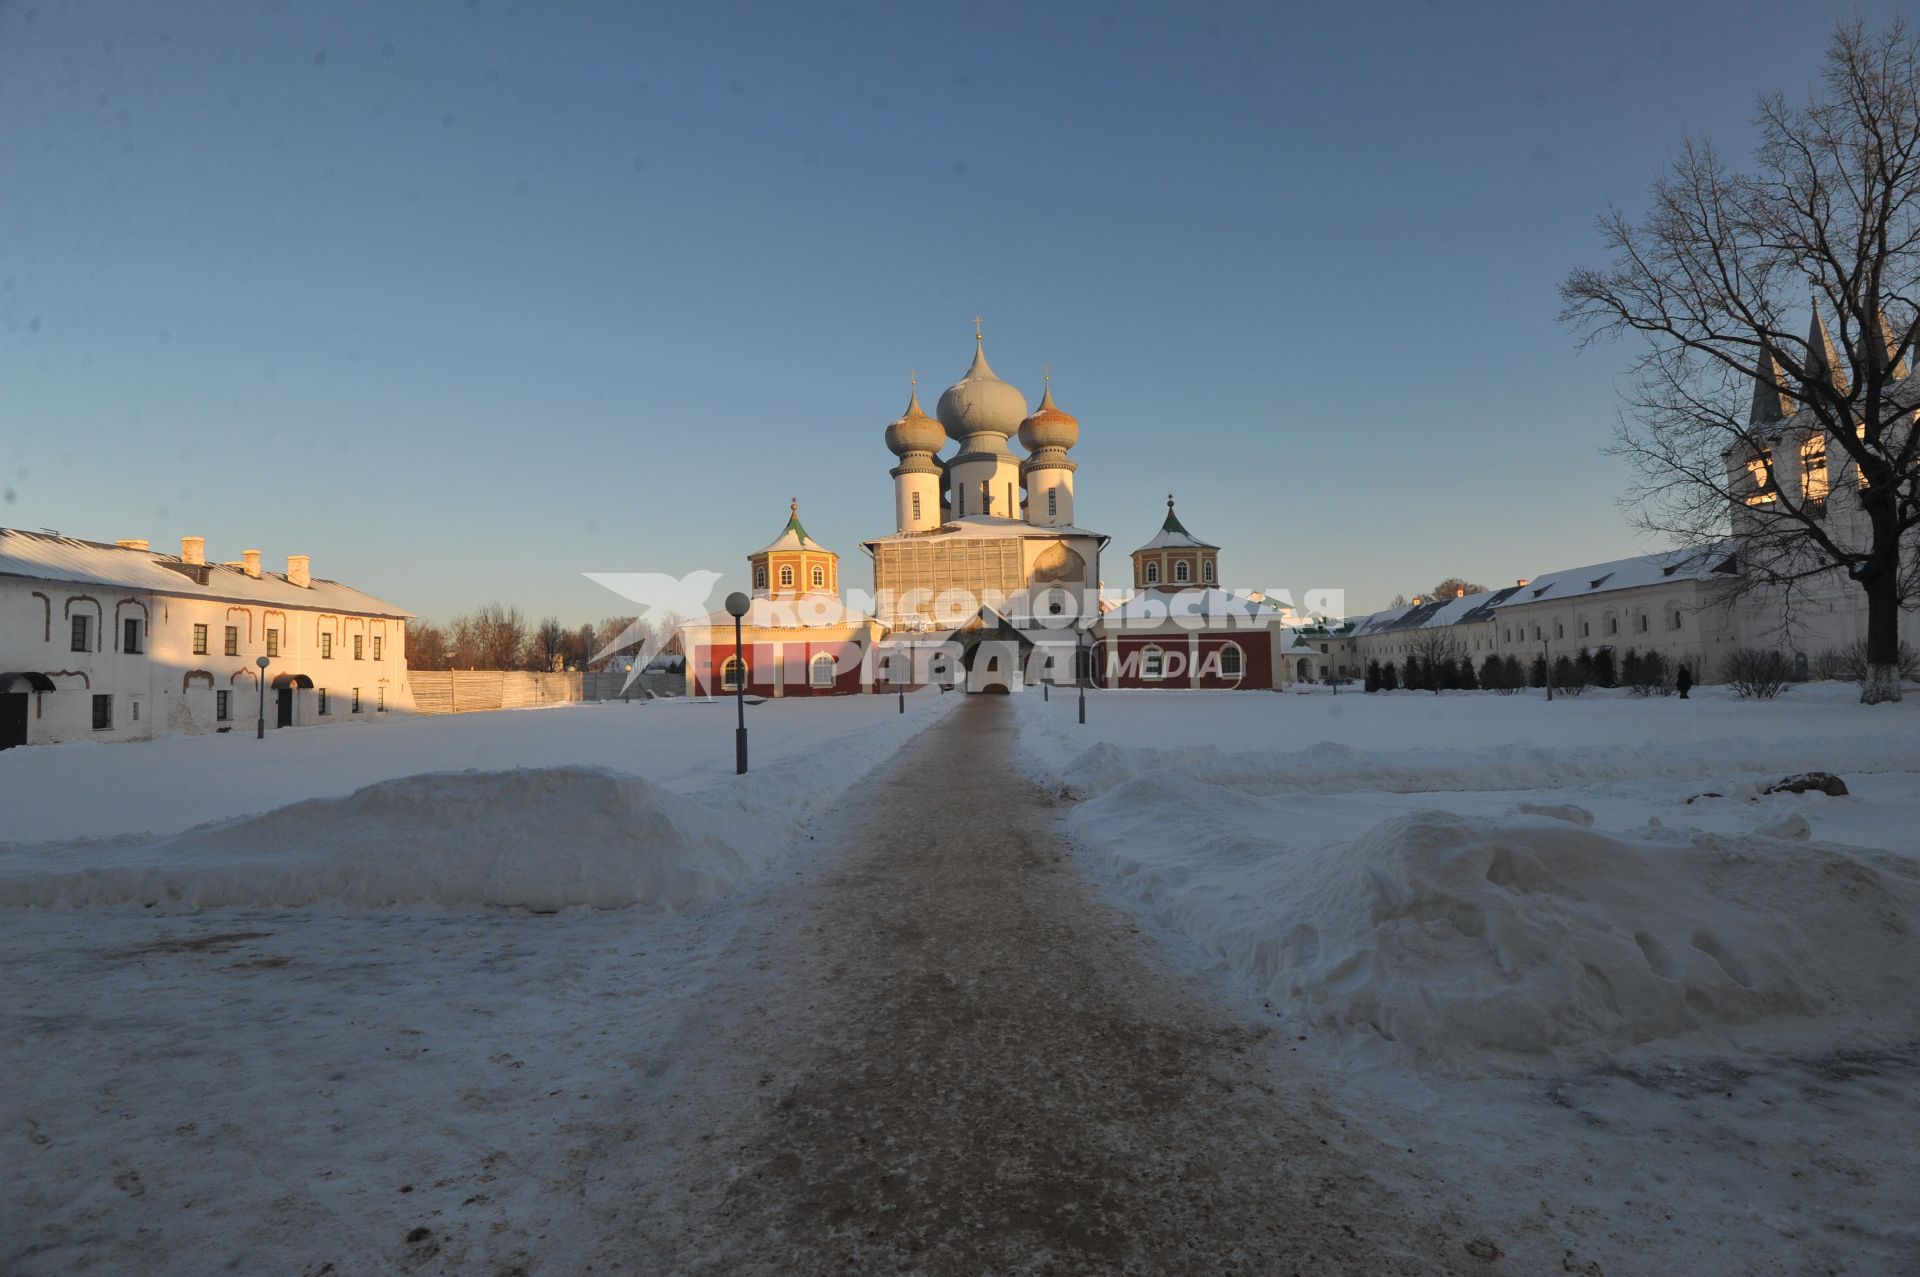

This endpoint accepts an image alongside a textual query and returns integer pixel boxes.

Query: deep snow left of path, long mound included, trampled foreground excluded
[0,695,954,910]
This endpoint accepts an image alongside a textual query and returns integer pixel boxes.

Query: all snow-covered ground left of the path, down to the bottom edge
[0,691,960,1273]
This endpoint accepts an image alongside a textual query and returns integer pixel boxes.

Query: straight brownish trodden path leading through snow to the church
[606,697,1492,1273]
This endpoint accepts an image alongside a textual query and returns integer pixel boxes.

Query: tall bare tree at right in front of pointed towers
[1561,21,1920,703]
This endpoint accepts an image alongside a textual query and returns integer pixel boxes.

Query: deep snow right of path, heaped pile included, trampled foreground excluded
[1018,695,1920,1073]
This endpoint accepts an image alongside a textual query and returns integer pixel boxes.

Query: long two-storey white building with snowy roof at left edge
[0,528,411,749]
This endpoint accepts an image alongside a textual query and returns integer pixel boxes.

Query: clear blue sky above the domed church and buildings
[0,0,1893,620]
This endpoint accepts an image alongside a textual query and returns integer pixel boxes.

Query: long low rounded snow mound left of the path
[0,766,766,910]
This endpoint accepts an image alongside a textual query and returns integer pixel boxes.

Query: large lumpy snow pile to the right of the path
[1071,778,1920,1072]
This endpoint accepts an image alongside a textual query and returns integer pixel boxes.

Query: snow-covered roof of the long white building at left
[0,528,413,616]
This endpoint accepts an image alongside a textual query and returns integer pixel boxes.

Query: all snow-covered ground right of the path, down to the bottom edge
[1016,686,1920,1273]
